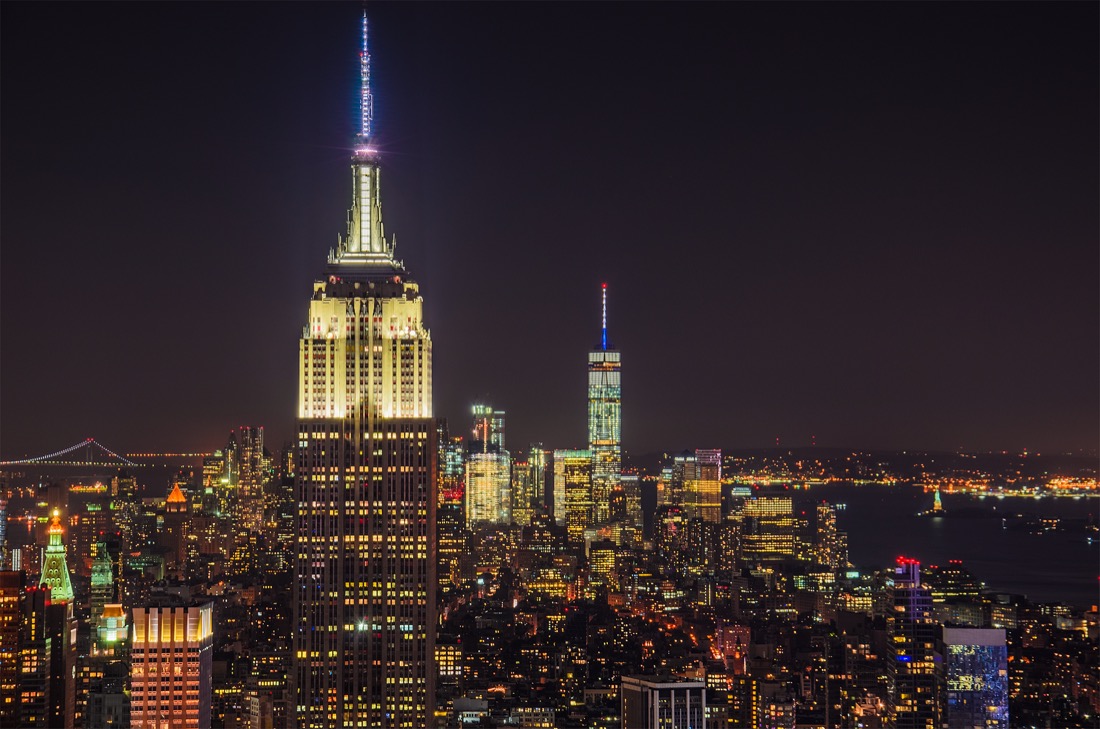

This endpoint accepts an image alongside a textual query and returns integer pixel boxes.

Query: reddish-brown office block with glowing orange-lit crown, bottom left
[130,597,213,729]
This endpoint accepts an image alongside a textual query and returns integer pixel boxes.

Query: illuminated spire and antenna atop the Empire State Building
[329,12,405,269]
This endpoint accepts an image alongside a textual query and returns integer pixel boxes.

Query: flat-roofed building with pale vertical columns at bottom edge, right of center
[622,676,706,729]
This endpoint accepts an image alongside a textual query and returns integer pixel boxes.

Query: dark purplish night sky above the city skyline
[0,2,1100,457]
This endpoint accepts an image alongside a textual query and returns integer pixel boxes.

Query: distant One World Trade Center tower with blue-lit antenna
[589,284,623,526]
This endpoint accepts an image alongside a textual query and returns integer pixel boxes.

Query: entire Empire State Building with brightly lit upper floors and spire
[292,15,437,727]
